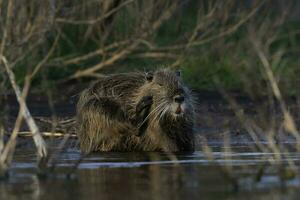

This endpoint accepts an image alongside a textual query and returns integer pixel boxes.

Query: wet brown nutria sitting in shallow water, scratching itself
[77,69,195,153]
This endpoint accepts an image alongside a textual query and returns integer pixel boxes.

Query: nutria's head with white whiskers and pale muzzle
[146,69,192,119]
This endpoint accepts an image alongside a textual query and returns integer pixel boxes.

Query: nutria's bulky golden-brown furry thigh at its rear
[77,97,137,153]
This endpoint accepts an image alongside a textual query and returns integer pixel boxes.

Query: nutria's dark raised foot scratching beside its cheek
[135,96,153,136]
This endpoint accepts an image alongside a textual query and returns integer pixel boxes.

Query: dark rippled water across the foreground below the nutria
[0,141,300,200]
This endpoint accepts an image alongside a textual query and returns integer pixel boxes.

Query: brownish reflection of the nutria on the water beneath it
[78,153,195,200]
